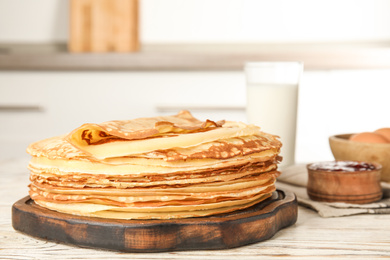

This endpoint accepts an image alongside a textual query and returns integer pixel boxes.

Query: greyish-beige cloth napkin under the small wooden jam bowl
[276,164,390,218]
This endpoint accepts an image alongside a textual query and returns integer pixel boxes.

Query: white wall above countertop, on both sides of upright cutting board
[0,0,390,43]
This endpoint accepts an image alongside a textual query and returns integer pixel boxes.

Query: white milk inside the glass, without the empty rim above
[246,84,298,168]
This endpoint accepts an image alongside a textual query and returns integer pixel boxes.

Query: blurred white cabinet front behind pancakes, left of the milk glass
[0,72,245,158]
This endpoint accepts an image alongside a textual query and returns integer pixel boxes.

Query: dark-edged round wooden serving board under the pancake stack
[12,190,298,252]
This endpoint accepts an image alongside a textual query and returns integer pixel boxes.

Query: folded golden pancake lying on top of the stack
[66,111,259,159]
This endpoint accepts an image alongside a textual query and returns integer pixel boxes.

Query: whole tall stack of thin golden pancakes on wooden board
[27,111,281,219]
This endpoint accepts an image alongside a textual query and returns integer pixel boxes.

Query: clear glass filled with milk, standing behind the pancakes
[245,62,303,169]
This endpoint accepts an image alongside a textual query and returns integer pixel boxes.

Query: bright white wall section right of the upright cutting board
[142,0,390,42]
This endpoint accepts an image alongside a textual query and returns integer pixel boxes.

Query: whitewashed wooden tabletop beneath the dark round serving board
[0,159,390,260]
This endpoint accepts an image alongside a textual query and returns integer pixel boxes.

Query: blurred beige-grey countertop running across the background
[0,42,390,71]
